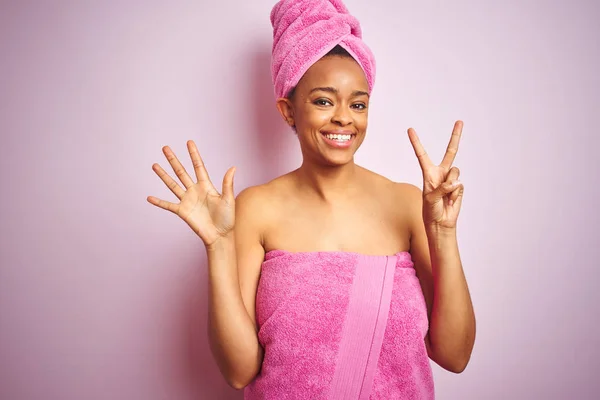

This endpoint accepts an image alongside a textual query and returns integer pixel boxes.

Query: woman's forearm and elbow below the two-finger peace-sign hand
[427,228,475,372]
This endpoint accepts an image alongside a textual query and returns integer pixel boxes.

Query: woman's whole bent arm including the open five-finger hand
[148,141,264,389]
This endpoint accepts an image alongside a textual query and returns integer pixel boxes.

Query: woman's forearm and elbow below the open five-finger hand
[207,238,262,388]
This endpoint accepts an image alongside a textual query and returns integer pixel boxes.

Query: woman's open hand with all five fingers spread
[147,140,235,248]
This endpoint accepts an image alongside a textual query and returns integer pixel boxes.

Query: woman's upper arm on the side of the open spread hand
[235,187,265,329]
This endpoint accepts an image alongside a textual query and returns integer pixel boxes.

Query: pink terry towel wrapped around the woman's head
[271,0,375,98]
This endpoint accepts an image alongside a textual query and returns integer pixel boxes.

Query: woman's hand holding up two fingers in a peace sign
[408,121,464,229]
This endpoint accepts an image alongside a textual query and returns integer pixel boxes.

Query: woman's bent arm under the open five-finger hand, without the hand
[206,188,265,389]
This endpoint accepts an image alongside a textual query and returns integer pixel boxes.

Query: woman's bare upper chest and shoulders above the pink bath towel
[246,166,410,255]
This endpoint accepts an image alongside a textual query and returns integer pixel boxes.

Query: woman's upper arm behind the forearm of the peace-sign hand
[404,184,434,356]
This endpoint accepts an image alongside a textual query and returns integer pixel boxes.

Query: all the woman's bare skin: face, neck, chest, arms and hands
[148,56,475,389]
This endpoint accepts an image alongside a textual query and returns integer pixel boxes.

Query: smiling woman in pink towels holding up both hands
[148,0,475,399]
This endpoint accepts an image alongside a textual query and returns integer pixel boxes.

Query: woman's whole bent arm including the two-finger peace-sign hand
[408,121,475,373]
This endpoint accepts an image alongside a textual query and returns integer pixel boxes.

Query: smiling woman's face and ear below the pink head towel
[278,56,369,166]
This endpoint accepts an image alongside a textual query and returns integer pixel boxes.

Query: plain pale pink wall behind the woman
[0,0,600,400]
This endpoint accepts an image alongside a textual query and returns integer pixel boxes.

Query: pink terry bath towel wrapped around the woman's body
[244,250,434,400]
